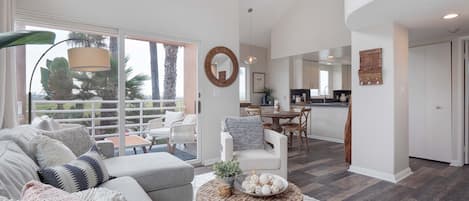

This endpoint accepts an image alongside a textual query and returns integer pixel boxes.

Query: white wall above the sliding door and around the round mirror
[17,0,239,162]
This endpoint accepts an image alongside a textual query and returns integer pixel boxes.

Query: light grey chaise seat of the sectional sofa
[104,153,194,192]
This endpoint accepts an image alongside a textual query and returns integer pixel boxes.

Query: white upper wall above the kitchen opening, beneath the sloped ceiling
[271,0,351,58]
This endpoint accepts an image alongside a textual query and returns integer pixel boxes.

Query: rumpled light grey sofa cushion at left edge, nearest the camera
[0,141,39,199]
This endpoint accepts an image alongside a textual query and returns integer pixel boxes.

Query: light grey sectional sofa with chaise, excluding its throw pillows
[0,126,194,201]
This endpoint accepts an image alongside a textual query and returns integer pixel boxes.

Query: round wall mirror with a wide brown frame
[205,47,239,87]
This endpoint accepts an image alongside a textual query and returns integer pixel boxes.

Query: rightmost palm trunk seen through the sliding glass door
[163,44,179,106]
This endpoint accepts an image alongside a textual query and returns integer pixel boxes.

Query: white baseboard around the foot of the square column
[348,165,412,183]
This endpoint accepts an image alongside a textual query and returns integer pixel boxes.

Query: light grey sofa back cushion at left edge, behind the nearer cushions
[0,126,37,161]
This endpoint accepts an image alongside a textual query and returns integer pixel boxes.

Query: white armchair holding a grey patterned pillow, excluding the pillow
[221,129,288,179]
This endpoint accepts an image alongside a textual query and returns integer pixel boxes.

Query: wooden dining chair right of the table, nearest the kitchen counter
[282,108,311,151]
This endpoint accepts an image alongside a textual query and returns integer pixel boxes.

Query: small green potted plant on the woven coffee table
[213,159,243,187]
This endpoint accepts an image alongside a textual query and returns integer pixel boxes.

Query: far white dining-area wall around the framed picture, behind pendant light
[239,44,269,104]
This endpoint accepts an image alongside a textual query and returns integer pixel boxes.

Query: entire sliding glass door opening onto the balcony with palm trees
[17,22,200,162]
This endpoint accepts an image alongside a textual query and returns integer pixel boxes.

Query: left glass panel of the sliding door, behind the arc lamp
[17,24,119,139]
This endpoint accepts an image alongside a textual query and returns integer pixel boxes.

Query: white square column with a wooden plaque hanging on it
[350,24,410,182]
